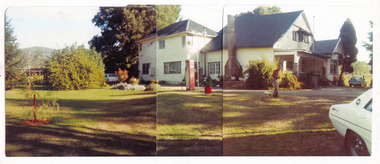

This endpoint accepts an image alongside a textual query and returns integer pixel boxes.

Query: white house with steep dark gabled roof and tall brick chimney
[203,11,343,81]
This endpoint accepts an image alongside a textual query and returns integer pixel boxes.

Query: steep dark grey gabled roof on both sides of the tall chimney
[206,11,303,51]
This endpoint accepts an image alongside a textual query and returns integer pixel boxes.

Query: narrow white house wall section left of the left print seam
[139,38,157,81]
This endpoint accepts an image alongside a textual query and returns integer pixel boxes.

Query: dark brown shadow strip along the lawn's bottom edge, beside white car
[223,131,348,156]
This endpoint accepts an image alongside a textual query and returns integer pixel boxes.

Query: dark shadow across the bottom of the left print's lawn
[6,124,156,156]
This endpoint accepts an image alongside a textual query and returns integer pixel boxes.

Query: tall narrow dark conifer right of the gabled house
[339,18,358,81]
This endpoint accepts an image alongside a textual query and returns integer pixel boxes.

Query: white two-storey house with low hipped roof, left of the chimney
[137,20,216,84]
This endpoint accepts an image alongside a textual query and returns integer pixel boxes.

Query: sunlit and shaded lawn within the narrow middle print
[157,90,223,156]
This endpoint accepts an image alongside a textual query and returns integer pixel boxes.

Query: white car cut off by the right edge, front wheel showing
[329,89,372,156]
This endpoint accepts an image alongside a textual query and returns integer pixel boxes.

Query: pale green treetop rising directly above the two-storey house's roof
[155,5,181,30]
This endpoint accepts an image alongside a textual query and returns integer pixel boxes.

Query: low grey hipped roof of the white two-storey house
[139,19,216,40]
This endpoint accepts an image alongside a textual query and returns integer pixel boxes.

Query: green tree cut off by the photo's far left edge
[4,17,22,89]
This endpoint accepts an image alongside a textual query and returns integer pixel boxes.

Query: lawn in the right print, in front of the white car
[223,93,352,156]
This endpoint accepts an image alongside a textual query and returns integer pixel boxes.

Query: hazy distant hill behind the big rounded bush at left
[21,47,55,68]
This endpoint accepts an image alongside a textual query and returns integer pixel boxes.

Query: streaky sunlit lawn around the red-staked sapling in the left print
[5,88,156,156]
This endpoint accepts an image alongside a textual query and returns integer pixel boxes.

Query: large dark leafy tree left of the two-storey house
[90,6,156,77]
